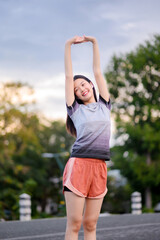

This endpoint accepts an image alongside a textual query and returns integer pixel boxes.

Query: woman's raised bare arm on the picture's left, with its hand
[64,36,84,106]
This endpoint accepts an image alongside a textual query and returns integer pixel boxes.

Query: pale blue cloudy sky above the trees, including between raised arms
[0,0,160,124]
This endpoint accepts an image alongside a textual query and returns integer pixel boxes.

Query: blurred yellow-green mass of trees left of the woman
[0,82,73,220]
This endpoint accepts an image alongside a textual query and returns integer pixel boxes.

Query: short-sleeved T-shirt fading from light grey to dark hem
[66,96,111,161]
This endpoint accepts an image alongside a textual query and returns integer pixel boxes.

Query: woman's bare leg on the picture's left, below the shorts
[65,191,85,240]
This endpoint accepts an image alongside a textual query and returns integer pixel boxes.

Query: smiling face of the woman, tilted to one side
[74,78,95,104]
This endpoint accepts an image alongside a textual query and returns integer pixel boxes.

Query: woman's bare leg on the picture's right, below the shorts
[83,198,103,240]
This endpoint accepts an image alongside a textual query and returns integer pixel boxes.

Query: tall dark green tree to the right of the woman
[105,35,160,208]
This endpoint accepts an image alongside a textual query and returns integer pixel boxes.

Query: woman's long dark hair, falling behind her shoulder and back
[66,75,97,137]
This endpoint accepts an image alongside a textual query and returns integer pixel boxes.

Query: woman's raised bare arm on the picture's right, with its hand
[84,36,110,102]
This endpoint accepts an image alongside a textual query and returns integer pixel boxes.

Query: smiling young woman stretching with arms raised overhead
[63,36,111,240]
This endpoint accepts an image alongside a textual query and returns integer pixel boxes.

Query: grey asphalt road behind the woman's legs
[0,213,160,240]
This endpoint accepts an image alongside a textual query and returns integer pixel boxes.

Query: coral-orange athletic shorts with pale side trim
[63,157,107,198]
